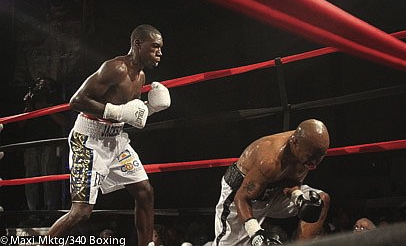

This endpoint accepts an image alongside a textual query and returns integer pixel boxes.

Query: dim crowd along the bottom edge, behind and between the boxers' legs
[61,204,406,246]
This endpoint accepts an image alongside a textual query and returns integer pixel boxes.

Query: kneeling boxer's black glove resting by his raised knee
[292,190,324,223]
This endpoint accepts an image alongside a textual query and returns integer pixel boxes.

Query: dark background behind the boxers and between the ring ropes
[0,0,406,221]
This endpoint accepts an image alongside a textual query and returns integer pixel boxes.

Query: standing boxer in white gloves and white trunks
[49,25,170,246]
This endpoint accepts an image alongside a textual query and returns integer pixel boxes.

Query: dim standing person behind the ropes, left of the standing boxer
[20,77,67,215]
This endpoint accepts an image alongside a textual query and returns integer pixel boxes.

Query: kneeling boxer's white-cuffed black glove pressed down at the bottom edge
[244,218,282,246]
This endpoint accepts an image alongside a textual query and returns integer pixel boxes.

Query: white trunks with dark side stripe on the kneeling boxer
[212,163,322,246]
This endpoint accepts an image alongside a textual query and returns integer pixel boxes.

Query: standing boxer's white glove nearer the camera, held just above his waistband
[103,99,148,128]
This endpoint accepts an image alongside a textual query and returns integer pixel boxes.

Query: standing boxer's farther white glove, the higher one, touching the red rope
[146,82,171,116]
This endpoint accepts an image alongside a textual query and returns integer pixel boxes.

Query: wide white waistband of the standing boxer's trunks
[73,114,124,138]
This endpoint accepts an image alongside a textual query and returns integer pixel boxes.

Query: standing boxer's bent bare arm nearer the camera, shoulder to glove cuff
[69,61,127,118]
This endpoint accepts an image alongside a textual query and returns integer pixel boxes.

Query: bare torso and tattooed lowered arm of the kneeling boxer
[234,120,328,230]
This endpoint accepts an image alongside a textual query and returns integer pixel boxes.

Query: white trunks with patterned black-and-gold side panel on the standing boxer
[69,114,148,204]
